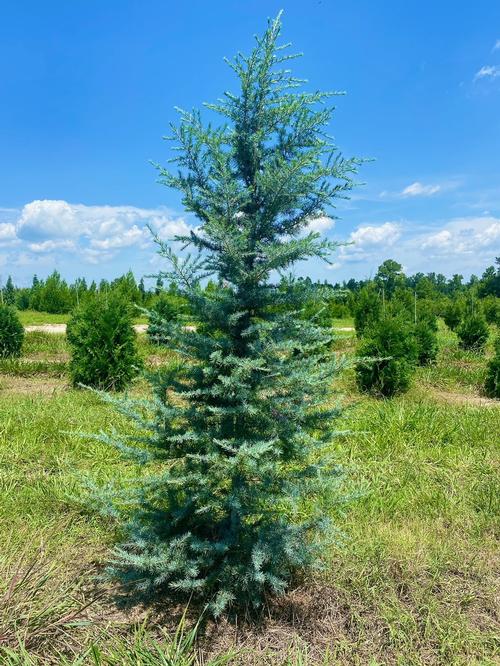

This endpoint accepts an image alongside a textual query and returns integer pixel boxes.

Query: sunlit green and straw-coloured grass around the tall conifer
[0,320,500,666]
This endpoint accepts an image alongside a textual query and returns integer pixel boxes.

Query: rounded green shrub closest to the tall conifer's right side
[356,316,418,397]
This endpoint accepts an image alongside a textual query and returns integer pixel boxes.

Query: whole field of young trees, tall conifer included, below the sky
[0,17,500,666]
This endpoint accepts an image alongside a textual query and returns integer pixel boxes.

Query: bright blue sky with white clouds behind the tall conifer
[0,0,500,284]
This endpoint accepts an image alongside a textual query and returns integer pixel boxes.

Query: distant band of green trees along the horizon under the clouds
[0,257,500,323]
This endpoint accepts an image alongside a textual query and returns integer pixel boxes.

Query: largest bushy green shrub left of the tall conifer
[67,293,140,391]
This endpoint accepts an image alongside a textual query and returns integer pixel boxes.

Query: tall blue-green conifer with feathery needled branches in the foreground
[100,17,359,615]
